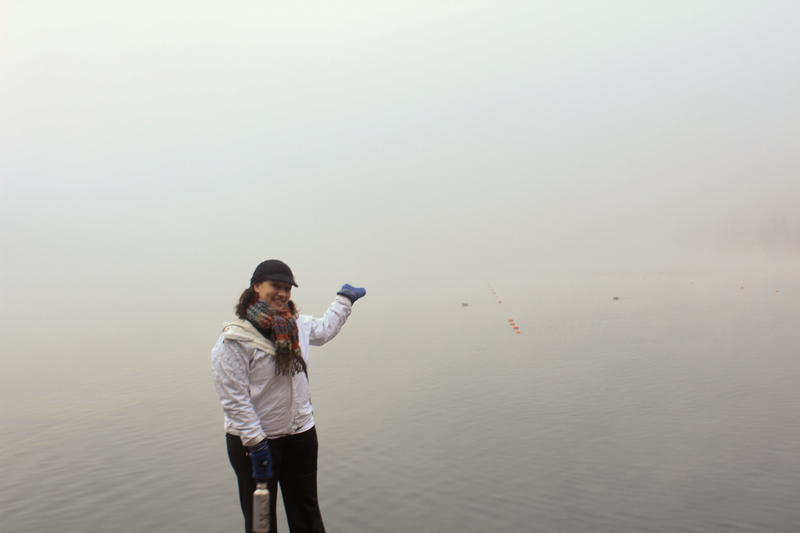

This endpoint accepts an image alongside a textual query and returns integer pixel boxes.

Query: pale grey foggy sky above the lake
[0,0,800,326]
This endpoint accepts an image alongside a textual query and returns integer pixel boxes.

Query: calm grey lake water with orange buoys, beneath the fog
[0,274,800,533]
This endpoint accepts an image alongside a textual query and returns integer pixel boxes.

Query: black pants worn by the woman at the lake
[225,427,325,533]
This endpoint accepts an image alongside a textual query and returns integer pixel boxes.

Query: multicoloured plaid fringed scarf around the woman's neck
[247,300,305,376]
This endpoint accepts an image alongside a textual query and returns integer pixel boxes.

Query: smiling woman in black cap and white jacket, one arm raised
[211,259,367,533]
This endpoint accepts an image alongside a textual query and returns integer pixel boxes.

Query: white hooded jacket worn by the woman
[211,296,353,446]
